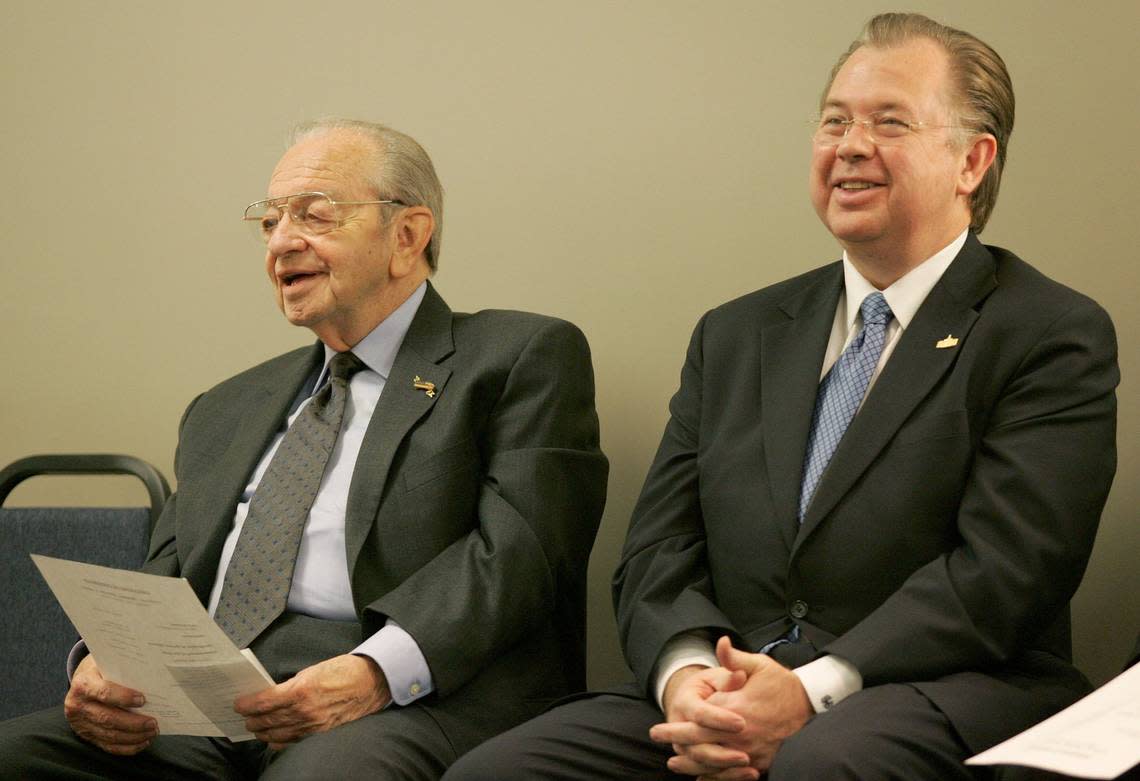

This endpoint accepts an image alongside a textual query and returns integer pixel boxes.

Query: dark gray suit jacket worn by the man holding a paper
[145,285,608,751]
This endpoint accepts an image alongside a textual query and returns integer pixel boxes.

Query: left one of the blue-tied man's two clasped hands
[649,666,750,778]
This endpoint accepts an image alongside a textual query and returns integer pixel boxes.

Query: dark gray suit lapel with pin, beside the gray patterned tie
[344,283,455,572]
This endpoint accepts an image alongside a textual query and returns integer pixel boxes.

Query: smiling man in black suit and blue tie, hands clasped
[446,14,1118,781]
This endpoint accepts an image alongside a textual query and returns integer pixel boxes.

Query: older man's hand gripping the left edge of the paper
[64,656,158,756]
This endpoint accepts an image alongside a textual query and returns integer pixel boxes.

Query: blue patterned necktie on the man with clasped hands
[799,291,894,522]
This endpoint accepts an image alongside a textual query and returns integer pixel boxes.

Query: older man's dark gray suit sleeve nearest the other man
[366,320,609,695]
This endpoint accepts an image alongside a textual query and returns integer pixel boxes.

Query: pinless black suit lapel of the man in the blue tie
[760,263,844,547]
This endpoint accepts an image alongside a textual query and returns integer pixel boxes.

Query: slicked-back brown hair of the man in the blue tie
[820,14,1013,233]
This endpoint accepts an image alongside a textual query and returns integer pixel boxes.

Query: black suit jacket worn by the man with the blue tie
[614,234,1118,749]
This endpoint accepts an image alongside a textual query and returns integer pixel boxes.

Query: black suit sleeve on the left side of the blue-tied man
[613,316,732,692]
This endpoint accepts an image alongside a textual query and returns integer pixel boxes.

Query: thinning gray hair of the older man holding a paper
[290,117,443,271]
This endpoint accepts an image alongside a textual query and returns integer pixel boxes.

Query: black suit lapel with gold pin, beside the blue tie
[796,234,996,548]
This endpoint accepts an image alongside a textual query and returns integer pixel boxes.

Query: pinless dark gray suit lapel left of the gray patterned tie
[184,342,324,602]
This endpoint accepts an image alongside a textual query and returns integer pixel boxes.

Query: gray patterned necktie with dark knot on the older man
[214,352,365,648]
